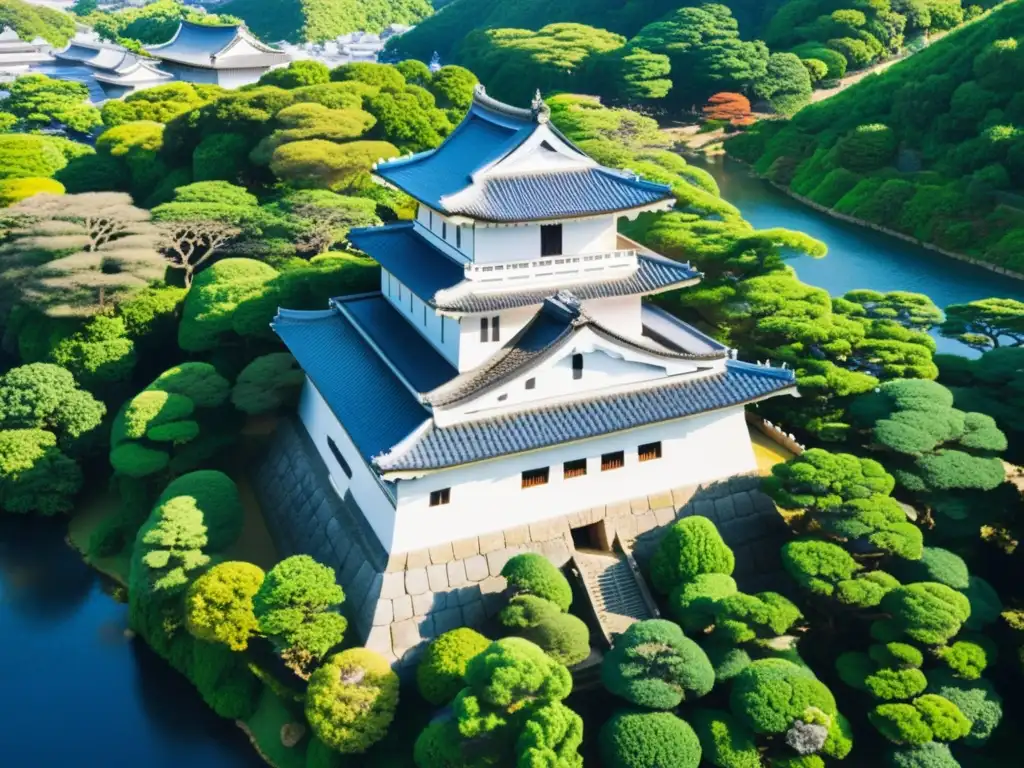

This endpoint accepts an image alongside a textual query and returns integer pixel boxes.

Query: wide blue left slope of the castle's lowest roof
[272,309,430,461]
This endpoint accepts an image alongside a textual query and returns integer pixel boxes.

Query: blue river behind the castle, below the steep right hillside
[693,157,1024,355]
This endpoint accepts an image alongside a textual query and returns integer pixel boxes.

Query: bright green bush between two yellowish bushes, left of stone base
[253,555,348,671]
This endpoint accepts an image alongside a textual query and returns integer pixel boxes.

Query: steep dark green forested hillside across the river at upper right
[726,2,1024,271]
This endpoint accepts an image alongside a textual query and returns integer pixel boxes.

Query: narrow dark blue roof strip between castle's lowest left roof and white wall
[335,293,459,392]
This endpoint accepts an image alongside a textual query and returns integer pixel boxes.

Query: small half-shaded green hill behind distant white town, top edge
[218,0,433,42]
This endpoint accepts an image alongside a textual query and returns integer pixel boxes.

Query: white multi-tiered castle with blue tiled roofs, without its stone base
[273,86,796,561]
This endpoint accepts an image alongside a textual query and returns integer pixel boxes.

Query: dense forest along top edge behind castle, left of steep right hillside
[388,0,980,115]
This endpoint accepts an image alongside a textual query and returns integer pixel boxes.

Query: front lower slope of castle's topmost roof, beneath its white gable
[442,168,672,221]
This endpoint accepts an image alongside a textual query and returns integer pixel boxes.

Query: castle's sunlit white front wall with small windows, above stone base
[391,407,757,552]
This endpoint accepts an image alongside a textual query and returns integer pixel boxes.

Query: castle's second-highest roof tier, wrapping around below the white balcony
[348,222,700,313]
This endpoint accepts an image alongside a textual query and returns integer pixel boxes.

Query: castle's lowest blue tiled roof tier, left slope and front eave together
[273,297,796,472]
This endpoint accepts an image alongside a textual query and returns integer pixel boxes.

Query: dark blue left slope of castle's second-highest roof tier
[348,221,465,302]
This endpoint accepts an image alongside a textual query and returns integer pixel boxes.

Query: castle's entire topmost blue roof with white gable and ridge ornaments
[375,86,673,222]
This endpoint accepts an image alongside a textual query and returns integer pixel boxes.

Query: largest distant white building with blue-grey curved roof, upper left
[145,22,292,88]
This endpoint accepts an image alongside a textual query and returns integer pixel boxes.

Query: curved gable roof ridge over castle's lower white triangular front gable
[424,291,727,407]
